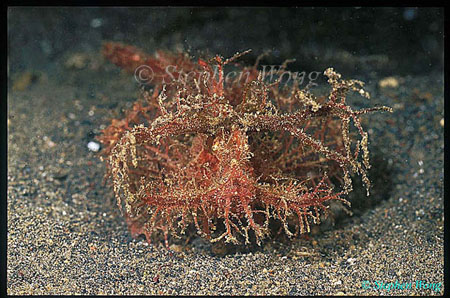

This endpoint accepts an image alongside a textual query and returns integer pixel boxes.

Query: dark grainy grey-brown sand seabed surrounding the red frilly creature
[7,7,444,295]
